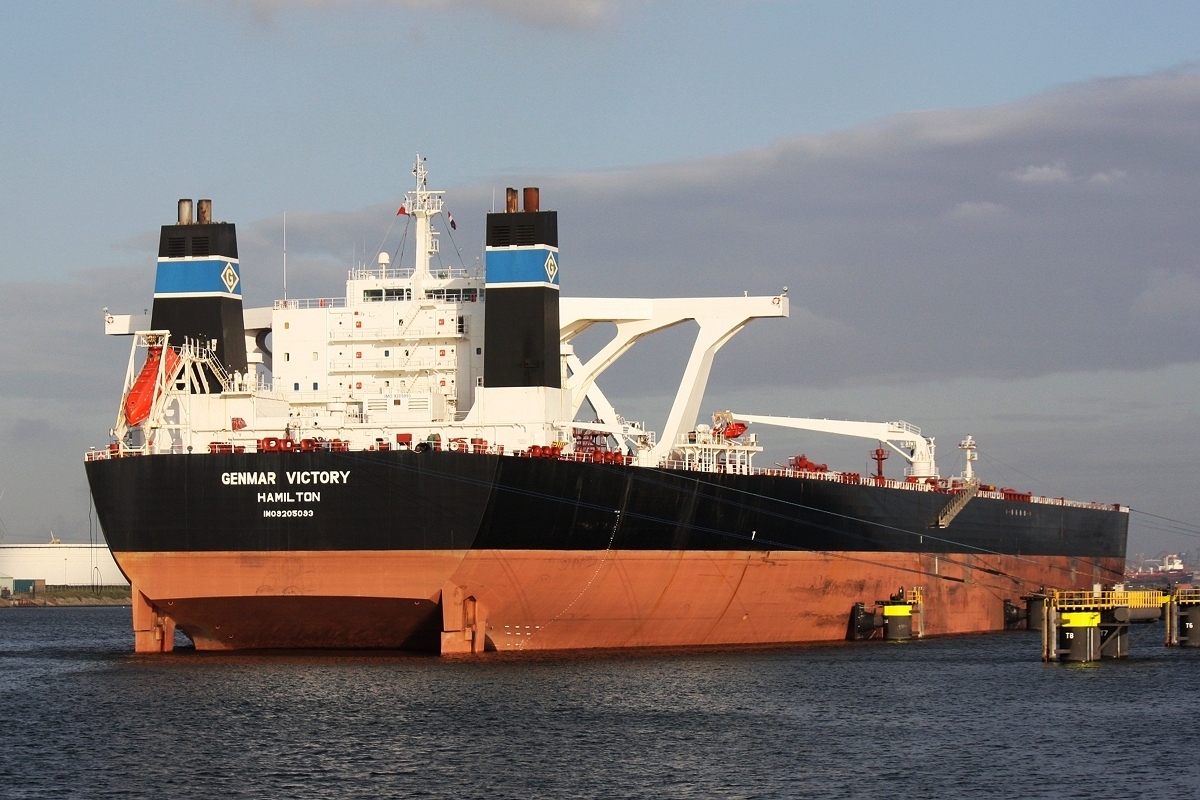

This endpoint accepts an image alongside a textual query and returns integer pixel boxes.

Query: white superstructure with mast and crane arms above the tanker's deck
[100,156,1089,501]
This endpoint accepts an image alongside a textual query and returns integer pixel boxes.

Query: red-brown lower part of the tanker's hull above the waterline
[114,551,1123,652]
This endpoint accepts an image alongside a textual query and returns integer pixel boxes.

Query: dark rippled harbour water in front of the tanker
[0,608,1200,798]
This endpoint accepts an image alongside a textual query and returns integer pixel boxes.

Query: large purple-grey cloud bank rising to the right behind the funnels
[88,73,1200,398]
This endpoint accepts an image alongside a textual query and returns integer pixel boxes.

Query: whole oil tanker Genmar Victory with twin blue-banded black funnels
[85,157,1128,654]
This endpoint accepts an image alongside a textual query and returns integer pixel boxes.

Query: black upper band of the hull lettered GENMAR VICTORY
[86,451,1128,558]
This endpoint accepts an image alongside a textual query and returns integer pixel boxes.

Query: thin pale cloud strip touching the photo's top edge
[224,0,620,29]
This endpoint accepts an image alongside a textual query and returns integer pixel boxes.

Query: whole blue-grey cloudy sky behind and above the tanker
[0,0,1200,563]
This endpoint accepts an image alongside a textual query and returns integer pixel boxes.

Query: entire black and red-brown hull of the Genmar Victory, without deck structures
[86,451,1128,652]
